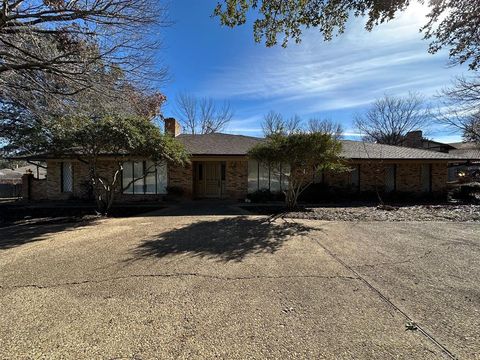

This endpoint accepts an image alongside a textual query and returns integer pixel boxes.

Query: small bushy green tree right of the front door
[249,113,346,209]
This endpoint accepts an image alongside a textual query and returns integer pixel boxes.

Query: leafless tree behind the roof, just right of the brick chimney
[175,93,233,134]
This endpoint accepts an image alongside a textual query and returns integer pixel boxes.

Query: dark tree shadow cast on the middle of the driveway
[131,216,309,262]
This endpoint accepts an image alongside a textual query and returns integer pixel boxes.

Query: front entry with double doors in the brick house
[194,161,225,198]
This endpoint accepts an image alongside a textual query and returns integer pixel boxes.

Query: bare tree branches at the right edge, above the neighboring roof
[437,75,480,145]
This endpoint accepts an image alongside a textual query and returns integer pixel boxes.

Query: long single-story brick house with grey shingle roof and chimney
[17,118,476,201]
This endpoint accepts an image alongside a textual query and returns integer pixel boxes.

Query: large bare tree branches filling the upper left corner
[0,0,166,98]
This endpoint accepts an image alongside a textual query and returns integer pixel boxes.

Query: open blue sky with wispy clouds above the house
[159,0,466,141]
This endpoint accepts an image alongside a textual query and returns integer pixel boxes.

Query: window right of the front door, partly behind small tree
[248,160,290,193]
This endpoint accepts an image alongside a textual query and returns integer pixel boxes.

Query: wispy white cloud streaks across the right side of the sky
[202,3,459,113]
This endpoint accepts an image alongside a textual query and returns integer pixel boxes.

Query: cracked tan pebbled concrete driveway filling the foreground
[0,213,480,359]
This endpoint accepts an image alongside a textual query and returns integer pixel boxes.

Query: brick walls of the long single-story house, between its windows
[25,158,448,201]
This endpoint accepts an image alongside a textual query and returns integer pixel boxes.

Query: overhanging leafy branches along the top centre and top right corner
[214,0,480,69]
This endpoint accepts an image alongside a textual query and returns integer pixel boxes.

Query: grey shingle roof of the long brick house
[177,133,480,161]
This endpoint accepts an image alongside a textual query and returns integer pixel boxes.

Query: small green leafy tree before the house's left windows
[49,116,189,215]
